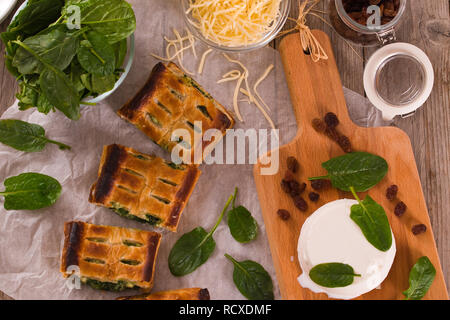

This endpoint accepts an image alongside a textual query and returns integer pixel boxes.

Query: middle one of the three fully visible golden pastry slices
[89,144,201,231]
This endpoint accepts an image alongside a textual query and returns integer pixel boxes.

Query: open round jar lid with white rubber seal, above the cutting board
[364,42,434,121]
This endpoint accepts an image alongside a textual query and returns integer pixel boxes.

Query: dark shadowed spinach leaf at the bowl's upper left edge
[7,0,64,35]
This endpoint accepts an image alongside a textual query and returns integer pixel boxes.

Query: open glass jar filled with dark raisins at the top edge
[329,0,406,46]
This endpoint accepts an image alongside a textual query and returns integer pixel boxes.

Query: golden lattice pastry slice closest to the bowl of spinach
[118,62,234,159]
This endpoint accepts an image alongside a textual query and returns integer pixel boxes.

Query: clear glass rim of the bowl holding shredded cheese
[181,0,291,52]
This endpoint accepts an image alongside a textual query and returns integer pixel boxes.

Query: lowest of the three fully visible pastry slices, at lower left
[61,221,161,291]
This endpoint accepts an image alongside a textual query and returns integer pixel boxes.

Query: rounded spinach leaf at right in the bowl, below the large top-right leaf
[77,31,116,76]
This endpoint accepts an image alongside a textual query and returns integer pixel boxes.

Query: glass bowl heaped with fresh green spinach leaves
[0,0,136,120]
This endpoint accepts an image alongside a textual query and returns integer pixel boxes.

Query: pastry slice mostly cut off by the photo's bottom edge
[116,288,210,300]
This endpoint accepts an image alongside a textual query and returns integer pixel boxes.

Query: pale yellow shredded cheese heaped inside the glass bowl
[186,0,281,47]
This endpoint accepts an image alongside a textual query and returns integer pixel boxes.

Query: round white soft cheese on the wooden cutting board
[297,199,396,299]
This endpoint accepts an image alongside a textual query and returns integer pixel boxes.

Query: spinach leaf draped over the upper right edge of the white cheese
[350,187,392,251]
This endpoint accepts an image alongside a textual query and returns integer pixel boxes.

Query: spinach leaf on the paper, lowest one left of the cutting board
[225,254,274,300]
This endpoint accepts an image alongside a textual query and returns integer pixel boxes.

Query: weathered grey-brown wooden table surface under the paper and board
[0,0,450,300]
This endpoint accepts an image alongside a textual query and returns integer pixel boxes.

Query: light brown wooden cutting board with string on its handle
[254,30,448,300]
